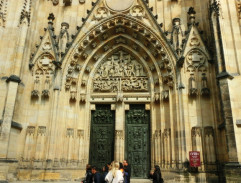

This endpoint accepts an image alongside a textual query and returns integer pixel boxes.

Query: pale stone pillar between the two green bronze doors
[112,102,125,162]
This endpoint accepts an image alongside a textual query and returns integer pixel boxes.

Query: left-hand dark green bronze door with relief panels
[89,105,115,168]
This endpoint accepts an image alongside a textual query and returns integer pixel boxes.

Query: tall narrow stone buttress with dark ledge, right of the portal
[210,1,238,163]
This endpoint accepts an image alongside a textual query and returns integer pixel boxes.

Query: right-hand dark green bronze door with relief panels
[125,105,150,178]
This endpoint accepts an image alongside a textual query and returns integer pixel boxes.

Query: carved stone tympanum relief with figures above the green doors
[93,51,148,92]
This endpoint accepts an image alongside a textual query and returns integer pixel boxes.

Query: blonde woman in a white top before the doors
[105,161,124,183]
